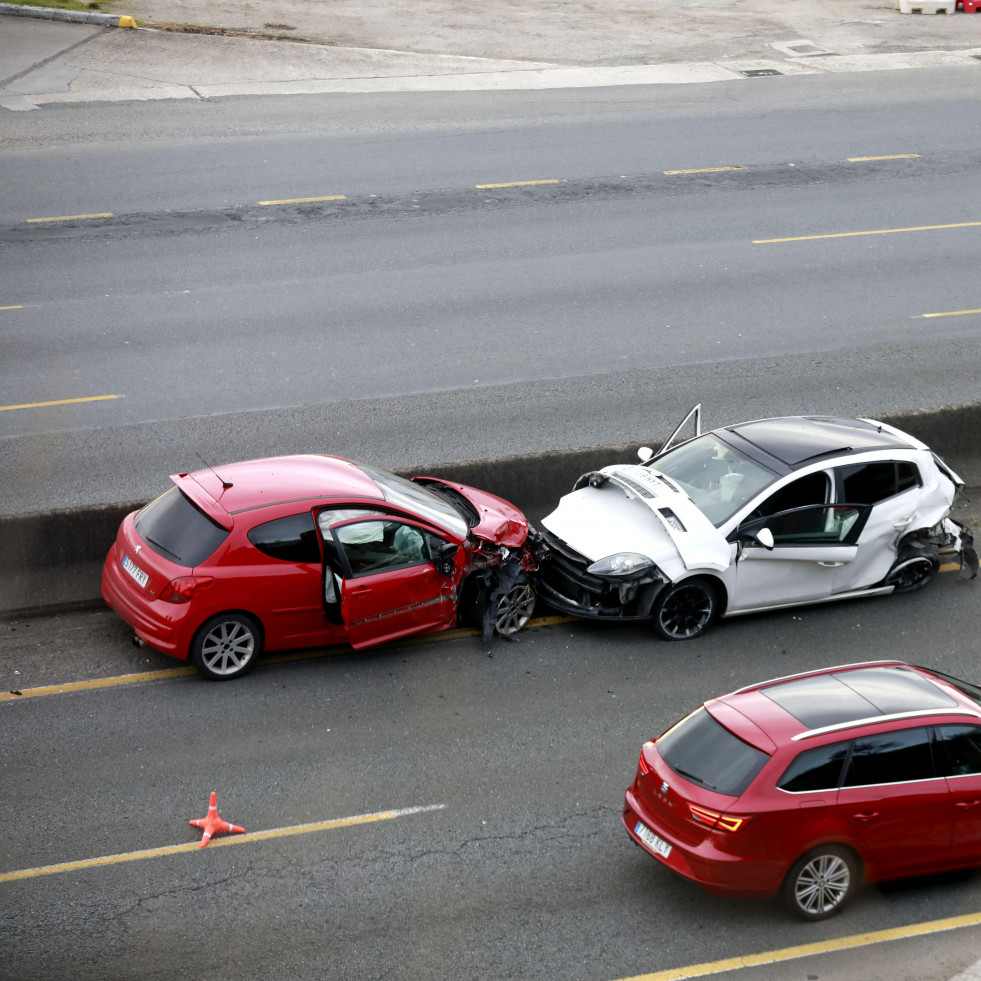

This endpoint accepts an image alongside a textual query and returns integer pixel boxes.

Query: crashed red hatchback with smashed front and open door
[102,455,535,680]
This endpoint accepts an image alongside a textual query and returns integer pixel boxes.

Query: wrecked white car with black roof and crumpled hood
[539,406,978,640]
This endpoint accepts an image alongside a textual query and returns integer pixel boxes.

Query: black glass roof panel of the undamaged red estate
[762,667,957,729]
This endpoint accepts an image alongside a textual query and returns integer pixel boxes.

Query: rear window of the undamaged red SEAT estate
[657,708,769,797]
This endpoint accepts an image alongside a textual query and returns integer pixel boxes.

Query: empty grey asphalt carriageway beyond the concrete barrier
[0,70,981,511]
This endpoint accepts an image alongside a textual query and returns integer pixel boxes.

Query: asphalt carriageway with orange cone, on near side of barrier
[0,574,981,981]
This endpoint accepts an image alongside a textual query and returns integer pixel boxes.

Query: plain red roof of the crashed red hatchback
[171,453,384,517]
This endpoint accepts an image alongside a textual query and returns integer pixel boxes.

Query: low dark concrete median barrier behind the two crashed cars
[0,403,981,618]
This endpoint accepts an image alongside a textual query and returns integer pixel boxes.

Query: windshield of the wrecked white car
[649,433,778,527]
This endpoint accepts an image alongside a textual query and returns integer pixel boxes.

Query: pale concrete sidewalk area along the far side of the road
[0,0,981,110]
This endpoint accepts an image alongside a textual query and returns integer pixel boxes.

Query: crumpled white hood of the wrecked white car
[542,464,732,581]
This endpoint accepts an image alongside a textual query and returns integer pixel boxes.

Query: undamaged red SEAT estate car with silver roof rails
[623,661,981,920]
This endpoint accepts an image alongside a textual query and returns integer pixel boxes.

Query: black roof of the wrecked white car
[717,416,916,469]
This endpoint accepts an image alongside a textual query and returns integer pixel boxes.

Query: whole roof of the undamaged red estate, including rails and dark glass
[706,661,981,748]
